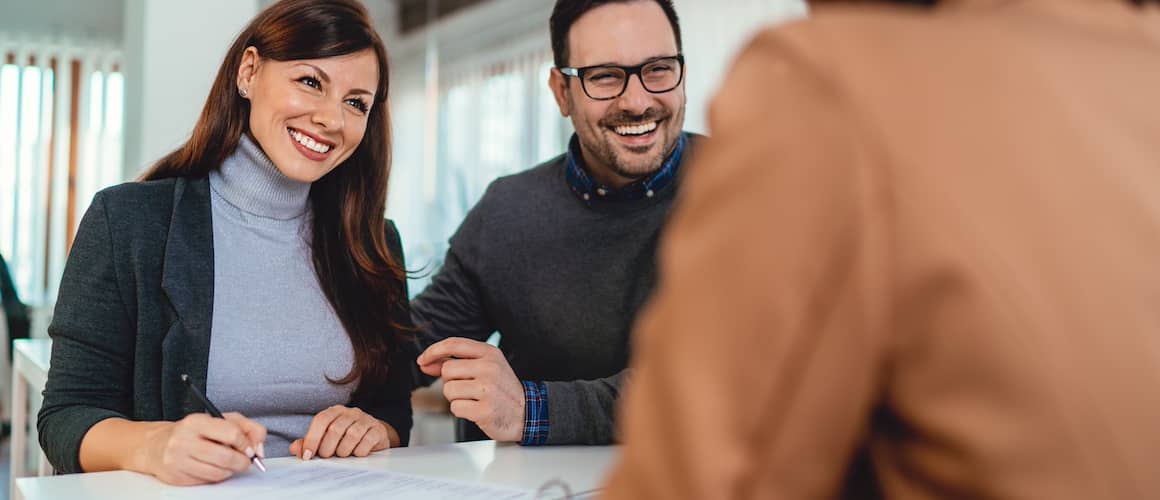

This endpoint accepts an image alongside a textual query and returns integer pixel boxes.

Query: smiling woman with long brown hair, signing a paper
[38,0,414,484]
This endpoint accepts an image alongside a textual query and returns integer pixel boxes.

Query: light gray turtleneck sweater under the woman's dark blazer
[205,135,355,457]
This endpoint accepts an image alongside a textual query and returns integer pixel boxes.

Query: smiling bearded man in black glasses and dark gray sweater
[413,0,696,444]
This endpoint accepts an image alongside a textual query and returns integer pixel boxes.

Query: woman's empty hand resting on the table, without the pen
[290,405,399,461]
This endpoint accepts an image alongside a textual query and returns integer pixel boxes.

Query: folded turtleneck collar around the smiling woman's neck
[210,133,311,220]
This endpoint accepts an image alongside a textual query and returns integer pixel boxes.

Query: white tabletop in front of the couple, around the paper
[13,441,618,500]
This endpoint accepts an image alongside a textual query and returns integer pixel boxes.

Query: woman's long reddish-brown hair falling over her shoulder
[142,0,409,397]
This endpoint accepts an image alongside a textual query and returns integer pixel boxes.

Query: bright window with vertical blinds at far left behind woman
[0,46,124,305]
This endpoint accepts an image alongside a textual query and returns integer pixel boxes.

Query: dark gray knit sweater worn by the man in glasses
[411,135,691,444]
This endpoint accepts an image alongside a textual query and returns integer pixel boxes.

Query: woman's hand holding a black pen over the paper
[131,413,266,486]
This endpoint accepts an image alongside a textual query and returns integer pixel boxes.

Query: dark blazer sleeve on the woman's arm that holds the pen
[37,194,136,472]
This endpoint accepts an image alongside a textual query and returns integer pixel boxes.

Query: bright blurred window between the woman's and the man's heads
[390,49,572,294]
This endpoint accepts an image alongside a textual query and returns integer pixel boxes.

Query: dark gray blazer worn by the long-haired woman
[37,177,415,472]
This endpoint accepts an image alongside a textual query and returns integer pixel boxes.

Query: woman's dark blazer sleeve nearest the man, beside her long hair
[351,220,418,447]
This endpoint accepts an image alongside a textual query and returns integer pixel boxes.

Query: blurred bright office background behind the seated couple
[0,0,806,489]
